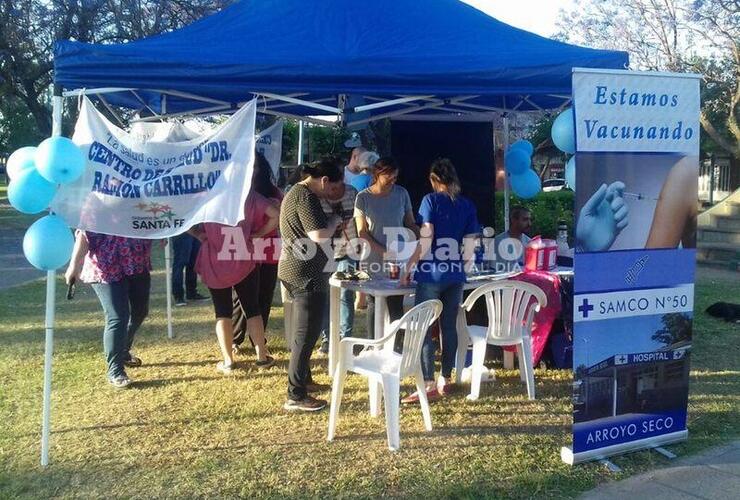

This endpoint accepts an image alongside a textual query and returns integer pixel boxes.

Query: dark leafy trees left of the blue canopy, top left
[0,0,233,143]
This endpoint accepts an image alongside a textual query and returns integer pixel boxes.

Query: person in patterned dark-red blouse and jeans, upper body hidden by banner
[65,230,152,389]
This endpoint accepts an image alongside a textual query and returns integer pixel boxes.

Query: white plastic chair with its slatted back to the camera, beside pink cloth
[457,280,547,400]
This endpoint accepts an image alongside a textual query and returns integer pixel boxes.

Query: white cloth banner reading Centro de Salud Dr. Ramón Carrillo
[51,99,256,239]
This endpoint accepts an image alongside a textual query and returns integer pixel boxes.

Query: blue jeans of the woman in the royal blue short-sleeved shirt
[416,283,463,381]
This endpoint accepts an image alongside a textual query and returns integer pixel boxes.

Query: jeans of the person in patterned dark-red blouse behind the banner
[92,271,151,377]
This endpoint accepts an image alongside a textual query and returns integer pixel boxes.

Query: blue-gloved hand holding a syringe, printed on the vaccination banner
[576,181,629,252]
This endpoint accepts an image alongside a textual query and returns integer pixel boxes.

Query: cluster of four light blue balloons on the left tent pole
[7,137,85,271]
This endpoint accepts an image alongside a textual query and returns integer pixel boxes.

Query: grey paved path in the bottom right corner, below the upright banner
[581,441,740,500]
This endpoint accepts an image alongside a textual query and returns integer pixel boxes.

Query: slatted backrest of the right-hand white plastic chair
[462,280,547,341]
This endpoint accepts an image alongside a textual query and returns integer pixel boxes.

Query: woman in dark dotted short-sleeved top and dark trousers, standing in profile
[278,158,344,411]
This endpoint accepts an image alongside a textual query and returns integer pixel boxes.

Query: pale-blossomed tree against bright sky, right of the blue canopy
[558,0,740,159]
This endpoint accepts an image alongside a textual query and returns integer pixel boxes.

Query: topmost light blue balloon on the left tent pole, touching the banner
[36,137,85,184]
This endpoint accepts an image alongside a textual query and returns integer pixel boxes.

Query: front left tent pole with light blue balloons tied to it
[41,85,64,467]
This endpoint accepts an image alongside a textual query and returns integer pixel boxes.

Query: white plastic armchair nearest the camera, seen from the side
[328,300,442,451]
